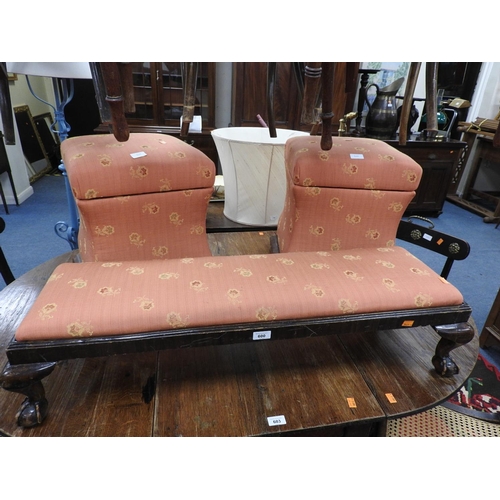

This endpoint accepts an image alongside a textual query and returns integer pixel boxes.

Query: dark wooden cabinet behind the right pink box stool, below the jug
[385,139,466,217]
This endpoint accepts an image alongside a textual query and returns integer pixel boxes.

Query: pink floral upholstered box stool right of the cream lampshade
[278,136,422,252]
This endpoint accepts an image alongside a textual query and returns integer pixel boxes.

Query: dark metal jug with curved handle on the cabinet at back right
[366,77,404,139]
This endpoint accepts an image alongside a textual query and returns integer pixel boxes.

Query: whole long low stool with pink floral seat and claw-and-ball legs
[0,242,473,427]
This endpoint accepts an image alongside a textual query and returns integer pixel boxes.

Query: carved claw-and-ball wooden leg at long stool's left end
[0,363,56,427]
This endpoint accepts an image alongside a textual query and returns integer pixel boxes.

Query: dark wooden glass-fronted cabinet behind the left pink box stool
[122,62,217,163]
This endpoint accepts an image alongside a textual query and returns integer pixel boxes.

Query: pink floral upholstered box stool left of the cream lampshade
[61,133,215,262]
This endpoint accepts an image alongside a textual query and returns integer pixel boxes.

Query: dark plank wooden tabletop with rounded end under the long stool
[0,231,478,436]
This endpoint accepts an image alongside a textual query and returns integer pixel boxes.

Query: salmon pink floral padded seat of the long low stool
[16,247,463,341]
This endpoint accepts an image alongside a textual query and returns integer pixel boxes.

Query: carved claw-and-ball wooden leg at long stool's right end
[432,323,474,377]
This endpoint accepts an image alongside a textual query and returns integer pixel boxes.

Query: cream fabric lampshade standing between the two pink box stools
[212,127,309,226]
